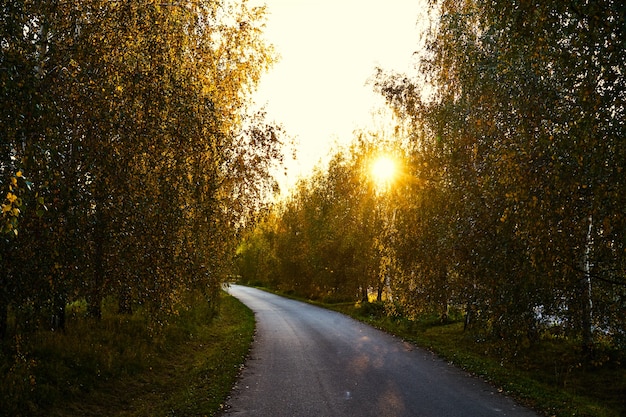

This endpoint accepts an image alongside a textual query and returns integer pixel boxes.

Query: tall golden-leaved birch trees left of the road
[0,0,282,339]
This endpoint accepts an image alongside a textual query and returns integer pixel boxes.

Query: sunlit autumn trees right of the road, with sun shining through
[238,0,626,361]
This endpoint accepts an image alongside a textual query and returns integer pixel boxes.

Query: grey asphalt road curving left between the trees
[225,285,537,417]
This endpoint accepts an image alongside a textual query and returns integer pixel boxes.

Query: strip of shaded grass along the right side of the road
[332,304,626,417]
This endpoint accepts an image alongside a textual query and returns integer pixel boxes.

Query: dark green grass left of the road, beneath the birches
[0,294,254,417]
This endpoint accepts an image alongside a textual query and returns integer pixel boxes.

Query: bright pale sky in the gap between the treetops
[255,0,426,192]
